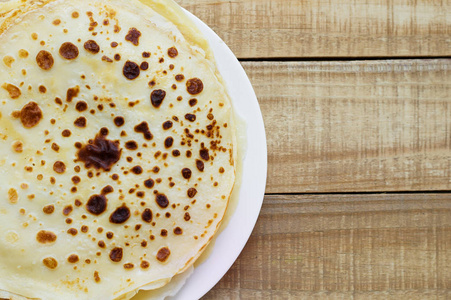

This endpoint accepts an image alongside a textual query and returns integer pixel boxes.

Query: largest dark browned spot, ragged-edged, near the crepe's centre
[77,134,122,171]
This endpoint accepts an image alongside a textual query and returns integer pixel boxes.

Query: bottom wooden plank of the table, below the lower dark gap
[204,194,451,300]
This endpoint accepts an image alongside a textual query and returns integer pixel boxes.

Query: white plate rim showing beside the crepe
[141,6,267,300]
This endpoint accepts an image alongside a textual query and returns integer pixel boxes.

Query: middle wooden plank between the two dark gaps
[243,59,451,193]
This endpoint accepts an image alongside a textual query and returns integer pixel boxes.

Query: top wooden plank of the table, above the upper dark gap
[176,0,451,58]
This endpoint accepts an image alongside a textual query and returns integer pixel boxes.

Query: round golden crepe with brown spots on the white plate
[0,0,237,299]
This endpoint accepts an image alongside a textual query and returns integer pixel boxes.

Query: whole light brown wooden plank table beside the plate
[177,0,451,300]
